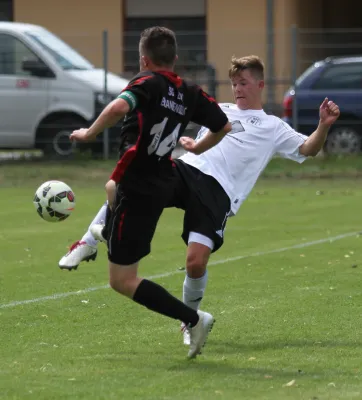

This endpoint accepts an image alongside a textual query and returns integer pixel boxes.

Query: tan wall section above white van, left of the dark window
[14,0,123,74]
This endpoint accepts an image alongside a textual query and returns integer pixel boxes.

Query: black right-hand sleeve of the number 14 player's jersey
[191,87,228,132]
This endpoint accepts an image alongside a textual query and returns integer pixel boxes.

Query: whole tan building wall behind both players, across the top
[14,0,332,102]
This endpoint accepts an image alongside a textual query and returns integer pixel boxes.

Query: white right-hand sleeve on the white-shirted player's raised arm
[275,118,308,163]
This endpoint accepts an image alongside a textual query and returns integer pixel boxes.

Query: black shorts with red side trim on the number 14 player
[107,185,172,265]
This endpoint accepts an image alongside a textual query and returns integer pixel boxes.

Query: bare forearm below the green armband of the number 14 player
[70,98,130,142]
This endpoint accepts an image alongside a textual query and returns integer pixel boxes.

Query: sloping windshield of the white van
[26,30,94,70]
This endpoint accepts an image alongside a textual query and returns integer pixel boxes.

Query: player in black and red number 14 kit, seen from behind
[70,27,231,358]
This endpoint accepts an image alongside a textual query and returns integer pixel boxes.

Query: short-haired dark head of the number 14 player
[139,26,177,67]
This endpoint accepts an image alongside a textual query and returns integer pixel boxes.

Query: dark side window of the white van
[0,33,39,76]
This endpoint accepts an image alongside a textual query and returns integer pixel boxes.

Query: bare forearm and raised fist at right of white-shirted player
[299,97,340,157]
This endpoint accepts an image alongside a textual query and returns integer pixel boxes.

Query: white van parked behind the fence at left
[0,22,128,157]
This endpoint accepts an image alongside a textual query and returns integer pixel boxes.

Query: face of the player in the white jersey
[231,69,264,110]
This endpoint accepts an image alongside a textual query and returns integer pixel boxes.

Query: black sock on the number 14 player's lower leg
[133,279,199,327]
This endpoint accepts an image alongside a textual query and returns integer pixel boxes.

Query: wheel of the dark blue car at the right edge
[324,126,362,154]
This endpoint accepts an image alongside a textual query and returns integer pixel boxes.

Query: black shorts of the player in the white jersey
[167,160,230,252]
